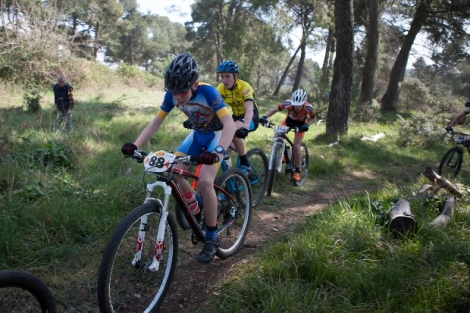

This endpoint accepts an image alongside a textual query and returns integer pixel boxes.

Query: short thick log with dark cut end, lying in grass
[389,200,418,235]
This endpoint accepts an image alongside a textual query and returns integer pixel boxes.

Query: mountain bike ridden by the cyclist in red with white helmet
[264,122,308,196]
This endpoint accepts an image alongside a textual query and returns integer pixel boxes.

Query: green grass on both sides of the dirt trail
[0,87,470,312]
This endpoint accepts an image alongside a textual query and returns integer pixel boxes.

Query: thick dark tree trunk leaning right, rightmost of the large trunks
[380,0,432,112]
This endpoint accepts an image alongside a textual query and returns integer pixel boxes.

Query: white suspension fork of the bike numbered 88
[132,182,171,272]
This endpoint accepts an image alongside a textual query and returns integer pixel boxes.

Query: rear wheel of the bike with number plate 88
[215,168,252,259]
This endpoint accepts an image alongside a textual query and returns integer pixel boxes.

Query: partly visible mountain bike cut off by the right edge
[437,131,470,178]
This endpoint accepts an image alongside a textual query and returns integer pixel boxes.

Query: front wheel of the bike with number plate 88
[97,203,178,313]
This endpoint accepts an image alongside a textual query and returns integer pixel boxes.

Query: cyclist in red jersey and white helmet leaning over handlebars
[259,89,316,182]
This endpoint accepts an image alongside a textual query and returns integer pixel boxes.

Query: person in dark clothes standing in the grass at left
[52,75,75,131]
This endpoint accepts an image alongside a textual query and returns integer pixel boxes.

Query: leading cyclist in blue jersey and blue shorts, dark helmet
[121,52,235,263]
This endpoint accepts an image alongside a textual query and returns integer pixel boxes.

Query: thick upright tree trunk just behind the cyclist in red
[326,0,354,135]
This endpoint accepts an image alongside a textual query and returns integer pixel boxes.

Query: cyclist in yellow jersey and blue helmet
[217,61,259,175]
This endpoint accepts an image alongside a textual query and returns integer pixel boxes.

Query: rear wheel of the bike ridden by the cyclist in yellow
[246,148,269,207]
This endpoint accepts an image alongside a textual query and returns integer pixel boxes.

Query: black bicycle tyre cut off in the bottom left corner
[0,270,57,313]
